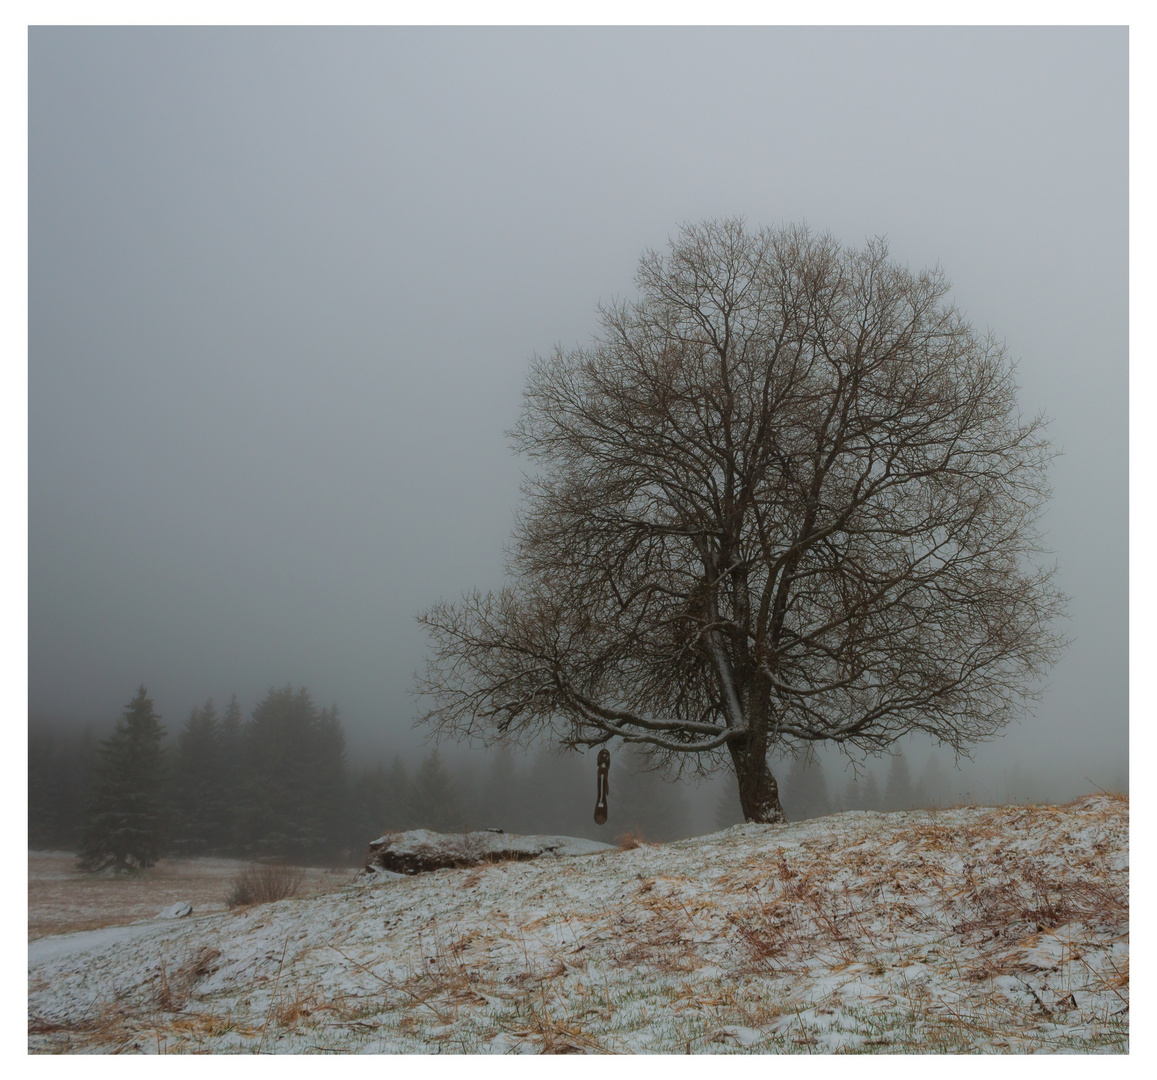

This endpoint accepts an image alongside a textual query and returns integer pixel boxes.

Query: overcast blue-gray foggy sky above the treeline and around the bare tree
[29,28,1128,783]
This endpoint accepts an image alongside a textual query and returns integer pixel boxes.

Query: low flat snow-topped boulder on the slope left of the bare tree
[362,829,614,877]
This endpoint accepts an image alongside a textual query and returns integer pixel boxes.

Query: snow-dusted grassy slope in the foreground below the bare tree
[29,795,1129,1053]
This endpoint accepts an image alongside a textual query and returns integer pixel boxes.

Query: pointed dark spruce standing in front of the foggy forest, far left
[80,686,168,870]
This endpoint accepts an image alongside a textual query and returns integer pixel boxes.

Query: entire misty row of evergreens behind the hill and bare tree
[29,686,985,867]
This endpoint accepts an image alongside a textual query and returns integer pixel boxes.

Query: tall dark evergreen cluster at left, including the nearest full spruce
[57,686,346,869]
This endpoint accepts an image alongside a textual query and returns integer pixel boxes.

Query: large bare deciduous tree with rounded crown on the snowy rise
[418,220,1064,822]
